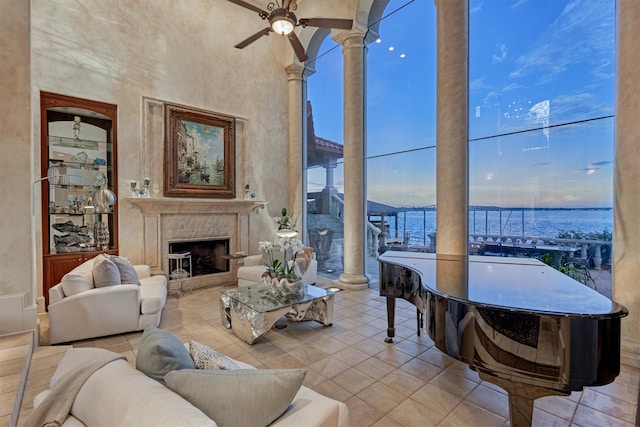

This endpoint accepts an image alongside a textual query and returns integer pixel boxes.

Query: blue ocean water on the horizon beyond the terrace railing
[386,209,613,245]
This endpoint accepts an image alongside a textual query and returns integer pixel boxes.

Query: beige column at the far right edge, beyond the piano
[612,0,640,368]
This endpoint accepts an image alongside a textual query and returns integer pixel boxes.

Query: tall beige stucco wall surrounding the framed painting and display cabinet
[26,0,298,312]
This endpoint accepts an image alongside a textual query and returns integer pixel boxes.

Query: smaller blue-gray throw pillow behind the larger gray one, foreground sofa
[136,326,196,384]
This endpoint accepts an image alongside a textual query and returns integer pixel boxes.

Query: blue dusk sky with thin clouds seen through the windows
[308,0,615,208]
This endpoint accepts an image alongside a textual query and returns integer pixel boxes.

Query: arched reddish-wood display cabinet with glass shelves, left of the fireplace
[40,92,118,305]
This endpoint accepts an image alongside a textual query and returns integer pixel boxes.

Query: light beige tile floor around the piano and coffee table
[31,287,640,427]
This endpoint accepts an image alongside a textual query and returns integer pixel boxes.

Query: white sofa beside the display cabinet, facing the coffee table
[48,255,167,344]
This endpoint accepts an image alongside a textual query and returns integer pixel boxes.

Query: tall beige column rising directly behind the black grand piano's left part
[435,0,469,256]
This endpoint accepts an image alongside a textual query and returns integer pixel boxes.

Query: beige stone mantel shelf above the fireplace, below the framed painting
[123,197,267,215]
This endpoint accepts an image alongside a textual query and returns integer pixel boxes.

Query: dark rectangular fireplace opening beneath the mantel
[169,239,229,277]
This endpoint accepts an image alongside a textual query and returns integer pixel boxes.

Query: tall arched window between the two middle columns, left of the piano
[366,0,436,284]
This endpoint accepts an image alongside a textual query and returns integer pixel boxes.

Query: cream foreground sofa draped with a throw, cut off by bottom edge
[34,348,349,427]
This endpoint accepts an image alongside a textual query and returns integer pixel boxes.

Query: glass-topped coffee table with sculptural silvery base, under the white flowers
[220,283,335,344]
